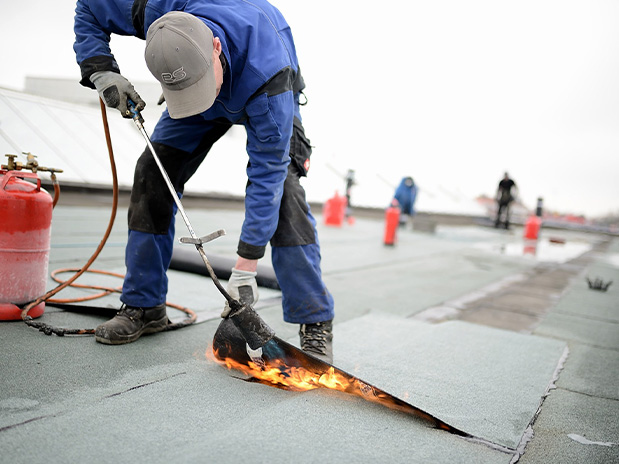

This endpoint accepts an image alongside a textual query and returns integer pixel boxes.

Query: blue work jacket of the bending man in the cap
[73,0,303,256]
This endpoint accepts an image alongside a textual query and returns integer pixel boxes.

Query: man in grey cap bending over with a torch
[74,0,334,362]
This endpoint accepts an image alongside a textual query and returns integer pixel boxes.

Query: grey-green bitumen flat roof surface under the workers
[0,205,619,463]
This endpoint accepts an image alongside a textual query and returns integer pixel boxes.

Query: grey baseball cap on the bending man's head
[144,11,217,119]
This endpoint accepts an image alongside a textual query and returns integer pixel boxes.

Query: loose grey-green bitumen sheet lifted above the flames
[335,313,565,449]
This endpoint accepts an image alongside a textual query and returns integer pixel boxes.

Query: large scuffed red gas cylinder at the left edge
[0,169,53,321]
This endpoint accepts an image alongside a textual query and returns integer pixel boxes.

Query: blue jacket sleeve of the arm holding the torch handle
[73,0,120,89]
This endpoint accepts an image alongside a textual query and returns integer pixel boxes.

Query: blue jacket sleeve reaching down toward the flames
[237,91,295,259]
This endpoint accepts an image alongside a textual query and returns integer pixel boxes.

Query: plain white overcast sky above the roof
[0,0,619,216]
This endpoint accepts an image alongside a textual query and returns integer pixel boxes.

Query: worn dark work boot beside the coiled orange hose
[95,304,168,345]
